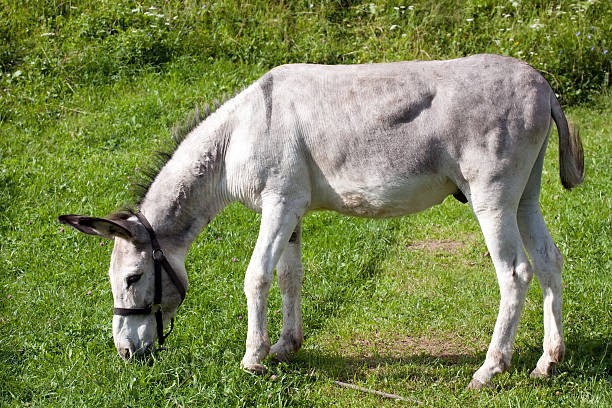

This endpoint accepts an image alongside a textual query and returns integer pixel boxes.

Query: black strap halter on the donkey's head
[113,212,186,347]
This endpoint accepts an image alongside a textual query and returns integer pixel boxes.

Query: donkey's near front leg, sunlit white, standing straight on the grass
[241,197,307,373]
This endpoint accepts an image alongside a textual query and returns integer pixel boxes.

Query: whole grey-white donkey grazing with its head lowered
[59,55,584,389]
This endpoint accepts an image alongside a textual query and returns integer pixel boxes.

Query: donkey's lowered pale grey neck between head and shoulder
[140,113,229,250]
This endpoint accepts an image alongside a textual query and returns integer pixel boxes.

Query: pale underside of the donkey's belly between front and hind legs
[310,175,457,218]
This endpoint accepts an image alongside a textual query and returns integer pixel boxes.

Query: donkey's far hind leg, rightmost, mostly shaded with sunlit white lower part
[517,145,565,377]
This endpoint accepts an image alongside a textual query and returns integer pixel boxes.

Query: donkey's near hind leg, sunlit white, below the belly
[468,192,532,389]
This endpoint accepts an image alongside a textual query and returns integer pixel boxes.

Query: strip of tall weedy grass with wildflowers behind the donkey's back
[0,0,612,125]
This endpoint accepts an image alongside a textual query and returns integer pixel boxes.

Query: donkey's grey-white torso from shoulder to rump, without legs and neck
[229,55,568,217]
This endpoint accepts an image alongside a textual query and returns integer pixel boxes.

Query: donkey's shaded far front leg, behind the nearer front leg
[270,222,304,361]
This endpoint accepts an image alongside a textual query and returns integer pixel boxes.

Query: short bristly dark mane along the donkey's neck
[127,98,227,208]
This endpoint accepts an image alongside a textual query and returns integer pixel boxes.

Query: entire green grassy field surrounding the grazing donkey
[0,0,612,407]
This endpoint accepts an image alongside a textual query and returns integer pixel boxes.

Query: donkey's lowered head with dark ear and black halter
[58,213,187,359]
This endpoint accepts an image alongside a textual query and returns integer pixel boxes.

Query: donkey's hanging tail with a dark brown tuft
[550,92,584,190]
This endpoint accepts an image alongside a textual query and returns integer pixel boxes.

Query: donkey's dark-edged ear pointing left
[57,214,134,240]
